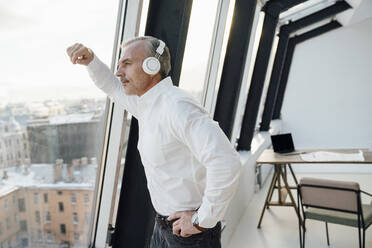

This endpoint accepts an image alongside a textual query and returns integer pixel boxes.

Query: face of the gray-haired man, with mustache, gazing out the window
[115,41,152,96]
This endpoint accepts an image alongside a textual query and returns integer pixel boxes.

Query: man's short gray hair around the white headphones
[121,36,171,79]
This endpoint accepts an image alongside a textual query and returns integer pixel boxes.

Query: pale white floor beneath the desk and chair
[228,174,372,248]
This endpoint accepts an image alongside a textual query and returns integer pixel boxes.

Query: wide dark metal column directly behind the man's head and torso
[112,0,192,247]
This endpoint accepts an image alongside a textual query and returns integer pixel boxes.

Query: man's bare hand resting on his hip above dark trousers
[168,210,201,237]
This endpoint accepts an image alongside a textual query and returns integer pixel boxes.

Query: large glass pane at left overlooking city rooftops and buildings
[0,0,119,248]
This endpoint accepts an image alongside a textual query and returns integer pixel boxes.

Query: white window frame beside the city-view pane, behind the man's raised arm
[91,0,143,247]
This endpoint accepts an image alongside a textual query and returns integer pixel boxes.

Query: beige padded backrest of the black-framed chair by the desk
[299,178,360,212]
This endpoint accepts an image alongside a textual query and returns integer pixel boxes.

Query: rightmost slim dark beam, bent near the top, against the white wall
[273,21,341,119]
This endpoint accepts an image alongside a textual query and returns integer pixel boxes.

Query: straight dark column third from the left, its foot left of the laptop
[238,2,281,150]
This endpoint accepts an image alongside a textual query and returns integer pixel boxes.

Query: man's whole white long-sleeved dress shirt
[88,56,241,228]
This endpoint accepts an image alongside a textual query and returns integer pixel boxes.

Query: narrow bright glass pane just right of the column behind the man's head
[179,0,219,102]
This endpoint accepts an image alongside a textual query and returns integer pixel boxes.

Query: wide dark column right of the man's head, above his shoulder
[214,0,257,138]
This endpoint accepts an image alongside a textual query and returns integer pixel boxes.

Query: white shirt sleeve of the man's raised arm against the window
[87,55,138,117]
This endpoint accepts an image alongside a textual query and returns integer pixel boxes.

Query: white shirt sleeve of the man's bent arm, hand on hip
[171,101,242,228]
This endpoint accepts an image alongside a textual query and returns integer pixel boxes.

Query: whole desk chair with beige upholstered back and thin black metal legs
[297,178,372,248]
